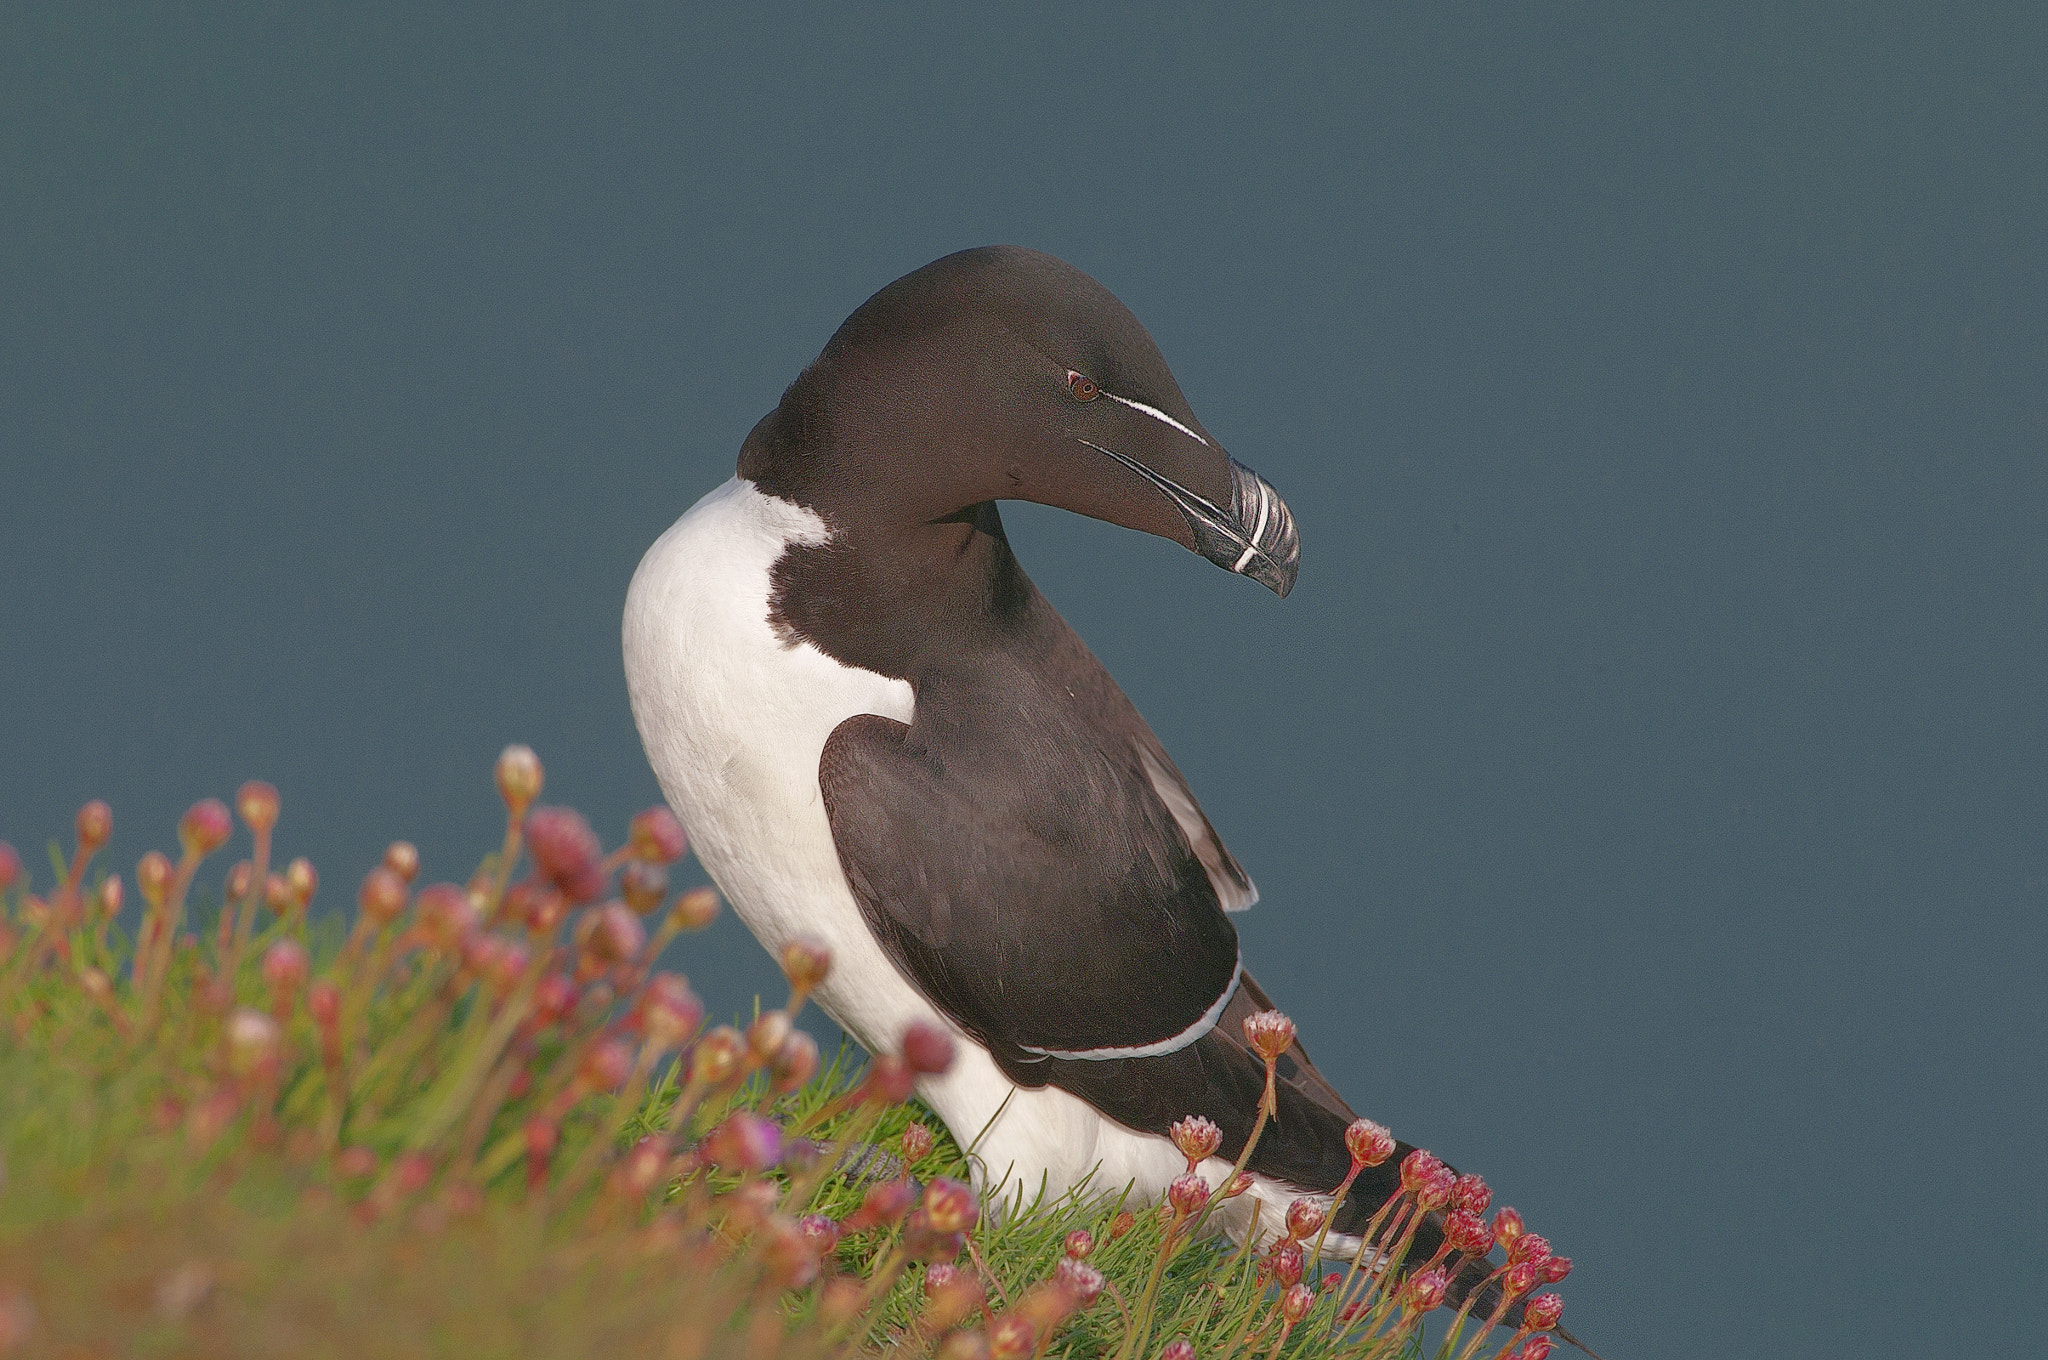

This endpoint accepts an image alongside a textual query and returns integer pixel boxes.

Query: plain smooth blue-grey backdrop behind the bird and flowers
[0,4,2048,1360]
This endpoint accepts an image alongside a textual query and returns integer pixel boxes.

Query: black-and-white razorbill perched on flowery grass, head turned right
[623,246,1548,1327]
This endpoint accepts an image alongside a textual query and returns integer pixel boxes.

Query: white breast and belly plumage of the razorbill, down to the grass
[625,477,1182,1198]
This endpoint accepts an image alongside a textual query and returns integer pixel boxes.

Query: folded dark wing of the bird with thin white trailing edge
[819,704,1243,1086]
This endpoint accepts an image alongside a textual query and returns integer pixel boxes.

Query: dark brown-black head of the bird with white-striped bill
[739,246,1300,596]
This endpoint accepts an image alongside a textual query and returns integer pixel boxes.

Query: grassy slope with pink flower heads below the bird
[0,746,1569,1360]
